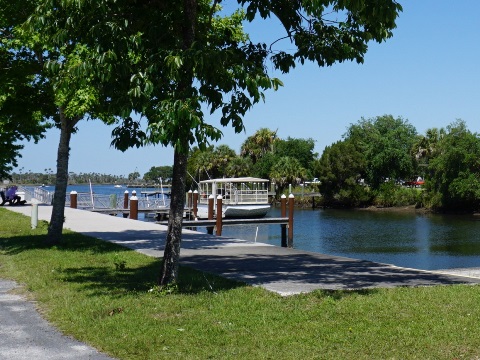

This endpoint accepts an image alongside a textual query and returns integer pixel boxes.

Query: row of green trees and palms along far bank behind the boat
[188,115,480,212]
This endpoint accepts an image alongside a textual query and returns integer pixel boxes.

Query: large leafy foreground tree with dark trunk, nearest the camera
[25,0,401,284]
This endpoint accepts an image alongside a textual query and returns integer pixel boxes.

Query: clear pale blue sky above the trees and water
[16,0,480,175]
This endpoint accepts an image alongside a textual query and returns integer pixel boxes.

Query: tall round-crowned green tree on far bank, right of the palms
[346,115,417,189]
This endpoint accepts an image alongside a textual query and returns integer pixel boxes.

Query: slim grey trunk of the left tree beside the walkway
[47,108,78,245]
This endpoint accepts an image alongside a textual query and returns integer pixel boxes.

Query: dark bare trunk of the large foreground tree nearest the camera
[159,143,188,285]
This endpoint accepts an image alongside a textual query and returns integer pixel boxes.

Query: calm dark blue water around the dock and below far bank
[38,185,480,270]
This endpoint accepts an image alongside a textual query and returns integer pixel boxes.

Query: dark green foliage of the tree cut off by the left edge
[0,1,51,179]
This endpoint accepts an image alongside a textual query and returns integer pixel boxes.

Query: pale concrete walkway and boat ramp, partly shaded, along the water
[7,205,480,295]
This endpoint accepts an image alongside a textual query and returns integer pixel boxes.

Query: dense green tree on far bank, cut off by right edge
[425,120,480,212]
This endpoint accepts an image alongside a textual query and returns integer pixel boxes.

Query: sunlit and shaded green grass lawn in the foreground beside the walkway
[0,208,480,359]
